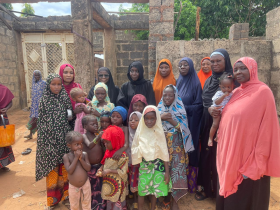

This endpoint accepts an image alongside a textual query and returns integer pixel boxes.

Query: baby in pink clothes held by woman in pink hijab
[70,88,90,134]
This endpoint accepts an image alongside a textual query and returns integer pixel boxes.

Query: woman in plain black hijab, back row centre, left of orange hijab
[117,61,156,110]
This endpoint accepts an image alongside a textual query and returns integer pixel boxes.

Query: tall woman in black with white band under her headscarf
[195,49,239,200]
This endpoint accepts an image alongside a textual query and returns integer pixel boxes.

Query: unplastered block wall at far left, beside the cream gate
[0,11,26,110]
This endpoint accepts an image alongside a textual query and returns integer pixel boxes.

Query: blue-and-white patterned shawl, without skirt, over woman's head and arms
[158,85,194,153]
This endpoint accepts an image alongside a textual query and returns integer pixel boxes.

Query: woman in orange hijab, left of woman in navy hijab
[153,59,176,105]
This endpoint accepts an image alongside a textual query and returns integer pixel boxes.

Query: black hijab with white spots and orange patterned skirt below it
[36,74,74,206]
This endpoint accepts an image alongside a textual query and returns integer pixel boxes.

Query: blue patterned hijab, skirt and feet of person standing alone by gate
[26,70,46,134]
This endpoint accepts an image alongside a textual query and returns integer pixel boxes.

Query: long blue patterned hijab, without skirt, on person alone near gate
[30,70,46,118]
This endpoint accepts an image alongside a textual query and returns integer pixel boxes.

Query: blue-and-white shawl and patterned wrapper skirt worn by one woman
[158,85,193,203]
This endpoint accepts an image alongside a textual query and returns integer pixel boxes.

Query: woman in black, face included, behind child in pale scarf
[88,67,120,106]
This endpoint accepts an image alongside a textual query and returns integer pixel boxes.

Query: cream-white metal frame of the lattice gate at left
[21,33,74,107]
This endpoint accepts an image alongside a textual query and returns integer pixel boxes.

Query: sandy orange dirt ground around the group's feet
[0,110,280,210]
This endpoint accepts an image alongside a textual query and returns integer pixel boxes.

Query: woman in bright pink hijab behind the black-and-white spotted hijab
[59,64,82,111]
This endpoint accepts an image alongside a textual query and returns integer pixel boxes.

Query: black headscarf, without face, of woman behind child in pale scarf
[88,67,119,105]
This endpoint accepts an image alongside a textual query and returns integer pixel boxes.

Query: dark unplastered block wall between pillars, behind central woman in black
[115,40,148,87]
